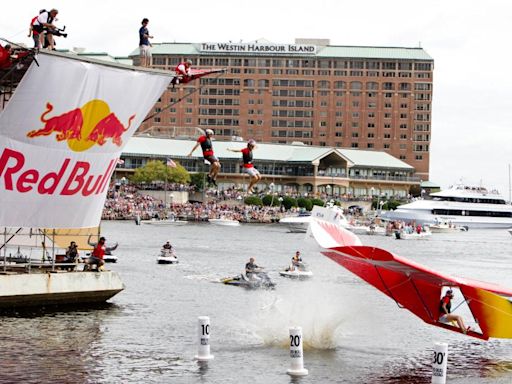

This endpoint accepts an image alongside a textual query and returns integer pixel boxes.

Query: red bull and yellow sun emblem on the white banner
[27,99,135,152]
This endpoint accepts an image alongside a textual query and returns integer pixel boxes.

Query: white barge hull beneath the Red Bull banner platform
[0,271,124,309]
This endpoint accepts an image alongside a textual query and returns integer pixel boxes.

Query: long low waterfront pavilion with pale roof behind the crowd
[116,136,420,197]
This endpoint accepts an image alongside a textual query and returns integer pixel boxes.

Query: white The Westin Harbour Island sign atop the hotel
[199,43,316,55]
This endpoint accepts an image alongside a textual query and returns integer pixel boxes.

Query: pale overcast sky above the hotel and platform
[0,0,512,199]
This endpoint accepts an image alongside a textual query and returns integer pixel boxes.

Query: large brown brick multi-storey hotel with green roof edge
[130,39,434,180]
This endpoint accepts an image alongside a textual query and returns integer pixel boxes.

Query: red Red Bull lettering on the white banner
[0,148,117,196]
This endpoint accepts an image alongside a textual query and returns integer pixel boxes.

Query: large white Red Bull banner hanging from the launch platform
[0,53,171,228]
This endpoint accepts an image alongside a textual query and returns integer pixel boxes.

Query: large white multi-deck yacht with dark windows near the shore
[382,184,512,228]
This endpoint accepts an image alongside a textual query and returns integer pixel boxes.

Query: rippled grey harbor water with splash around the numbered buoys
[0,222,512,384]
